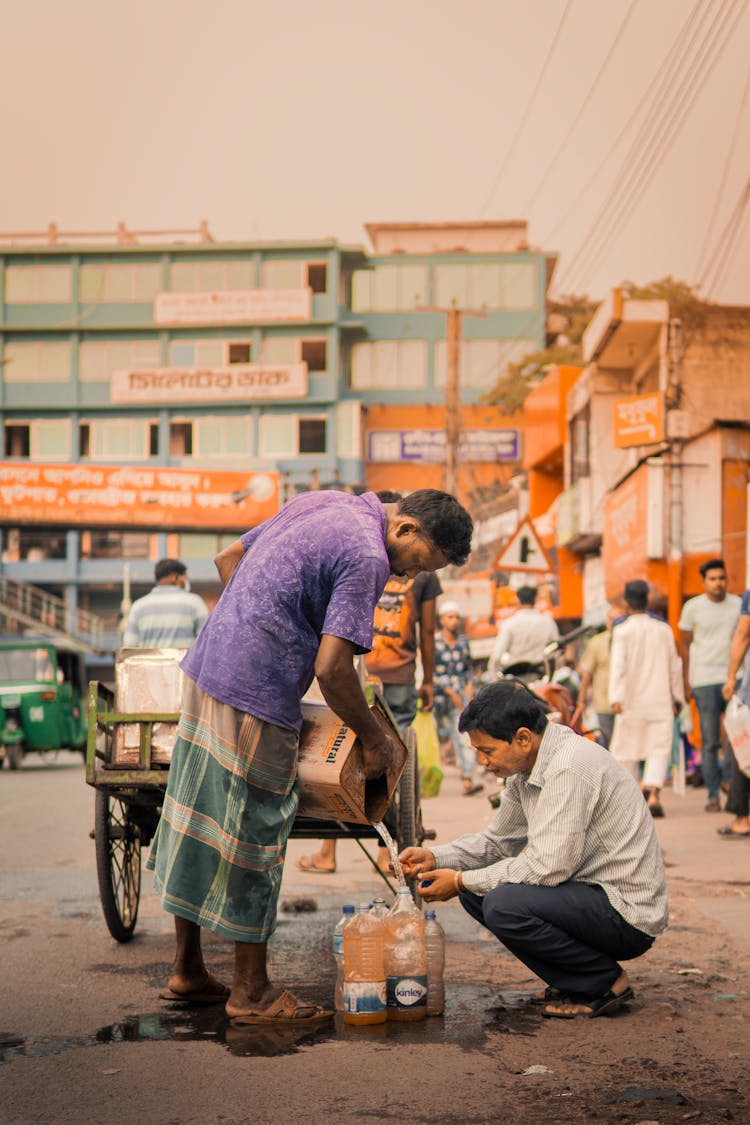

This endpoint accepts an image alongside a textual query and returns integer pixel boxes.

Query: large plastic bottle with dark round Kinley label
[383,887,427,1019]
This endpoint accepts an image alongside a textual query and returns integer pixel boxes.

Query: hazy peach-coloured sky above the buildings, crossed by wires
[0,0,750,304]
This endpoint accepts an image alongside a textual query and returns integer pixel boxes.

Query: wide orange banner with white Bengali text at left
[0,461,279,531]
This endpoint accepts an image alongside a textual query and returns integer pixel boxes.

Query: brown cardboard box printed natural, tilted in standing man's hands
[298,694,408,825]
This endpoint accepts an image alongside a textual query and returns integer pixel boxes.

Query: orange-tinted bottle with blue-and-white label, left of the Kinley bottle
[343,902,387,1024]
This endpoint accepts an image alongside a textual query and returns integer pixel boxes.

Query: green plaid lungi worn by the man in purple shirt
[147,677,298,942]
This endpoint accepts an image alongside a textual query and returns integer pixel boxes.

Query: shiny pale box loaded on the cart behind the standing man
[110,648,187,766]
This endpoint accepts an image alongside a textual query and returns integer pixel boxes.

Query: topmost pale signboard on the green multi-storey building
[154,288,313,324]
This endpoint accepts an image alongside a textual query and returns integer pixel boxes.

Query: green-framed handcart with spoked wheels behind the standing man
[85,680,427,942]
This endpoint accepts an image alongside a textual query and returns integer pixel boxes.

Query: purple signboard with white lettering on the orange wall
[368,430,521,464]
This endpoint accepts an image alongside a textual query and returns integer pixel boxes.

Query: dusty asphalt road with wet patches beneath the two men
[0,755,750,1125]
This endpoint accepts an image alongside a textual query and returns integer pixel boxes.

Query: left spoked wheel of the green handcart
[94,790,141,942]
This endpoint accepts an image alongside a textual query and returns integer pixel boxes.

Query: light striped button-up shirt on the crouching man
[430,722,668,936]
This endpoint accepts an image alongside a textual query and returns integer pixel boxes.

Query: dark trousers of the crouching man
[460,883,653,1000]
